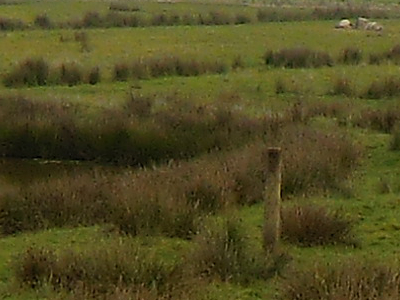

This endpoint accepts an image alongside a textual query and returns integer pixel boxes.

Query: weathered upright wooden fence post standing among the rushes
[263,147,282,253]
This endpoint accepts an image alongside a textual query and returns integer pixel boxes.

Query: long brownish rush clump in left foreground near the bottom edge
[13,243,177,297]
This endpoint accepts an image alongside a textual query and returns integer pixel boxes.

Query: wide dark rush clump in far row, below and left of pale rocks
[264,47,333,69]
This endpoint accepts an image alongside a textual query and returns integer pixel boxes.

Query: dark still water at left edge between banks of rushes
[0,158,121,185]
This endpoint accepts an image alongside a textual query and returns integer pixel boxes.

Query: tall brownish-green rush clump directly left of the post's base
[190,218,277,284]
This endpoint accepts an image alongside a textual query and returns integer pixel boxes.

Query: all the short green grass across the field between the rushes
[0,0,400,300]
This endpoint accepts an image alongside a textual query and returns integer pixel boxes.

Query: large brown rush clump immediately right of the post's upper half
[280,127,362,197]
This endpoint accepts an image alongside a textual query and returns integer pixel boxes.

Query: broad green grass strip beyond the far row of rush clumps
[0,19,400,76]
